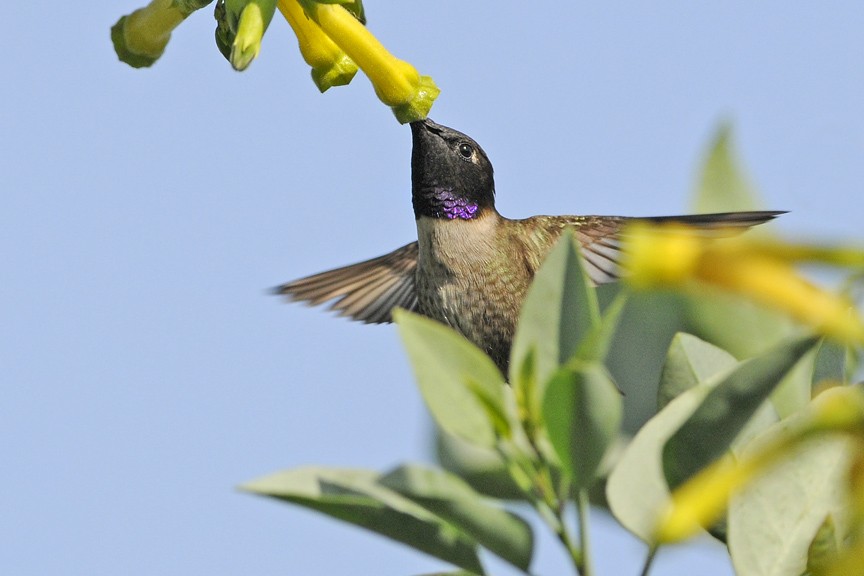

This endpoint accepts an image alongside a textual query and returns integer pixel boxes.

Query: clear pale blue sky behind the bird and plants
[0,0,864,576]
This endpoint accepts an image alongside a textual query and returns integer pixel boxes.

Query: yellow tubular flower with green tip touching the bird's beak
[303,0,440,124]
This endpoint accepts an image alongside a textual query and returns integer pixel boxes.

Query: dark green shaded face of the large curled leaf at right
[663,337,817,488]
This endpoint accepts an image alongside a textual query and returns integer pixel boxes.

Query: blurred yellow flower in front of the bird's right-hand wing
[625,224,864,343]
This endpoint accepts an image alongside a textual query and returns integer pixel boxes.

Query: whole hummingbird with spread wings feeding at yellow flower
[275,119,783,375]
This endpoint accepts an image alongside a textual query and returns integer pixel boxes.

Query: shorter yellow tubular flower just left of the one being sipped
[277,0,357,92]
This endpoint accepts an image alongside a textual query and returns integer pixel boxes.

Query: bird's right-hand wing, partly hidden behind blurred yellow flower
[562,211,785,284]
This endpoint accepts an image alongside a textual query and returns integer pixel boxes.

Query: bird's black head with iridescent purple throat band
[411,119,495,220]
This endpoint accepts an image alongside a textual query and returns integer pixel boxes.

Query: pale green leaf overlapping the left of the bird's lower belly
[393,310,510,447]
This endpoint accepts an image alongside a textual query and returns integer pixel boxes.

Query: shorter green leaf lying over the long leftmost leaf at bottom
[380,466,534,572]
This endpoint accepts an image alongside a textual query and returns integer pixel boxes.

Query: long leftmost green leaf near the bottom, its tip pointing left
[240,467,484,574]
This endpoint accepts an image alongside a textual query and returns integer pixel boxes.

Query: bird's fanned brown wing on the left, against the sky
[274,242,417,324]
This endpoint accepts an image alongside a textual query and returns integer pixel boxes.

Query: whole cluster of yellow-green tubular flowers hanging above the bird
[111,0,440,124]
